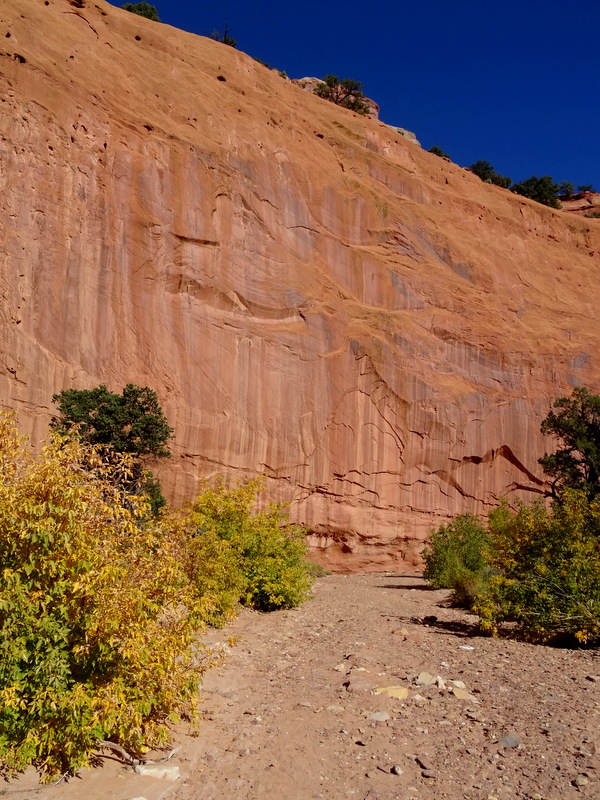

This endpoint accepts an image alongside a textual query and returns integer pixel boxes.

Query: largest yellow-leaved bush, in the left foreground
[0,415,203,777]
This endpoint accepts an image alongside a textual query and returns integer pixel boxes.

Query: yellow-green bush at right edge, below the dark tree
[476,490,600,643]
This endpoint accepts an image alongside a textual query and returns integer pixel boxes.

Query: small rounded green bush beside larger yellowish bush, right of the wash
[423,514,490,607]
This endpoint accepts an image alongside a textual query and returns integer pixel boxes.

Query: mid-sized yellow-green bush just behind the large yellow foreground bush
[186,479,311,611]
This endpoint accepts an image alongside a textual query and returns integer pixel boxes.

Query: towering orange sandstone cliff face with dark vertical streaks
[0,0,600,570]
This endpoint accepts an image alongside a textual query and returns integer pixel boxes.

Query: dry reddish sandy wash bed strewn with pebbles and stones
[5,574,600,800]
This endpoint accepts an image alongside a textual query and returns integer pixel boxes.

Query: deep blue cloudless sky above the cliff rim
[113,0,600,191]
